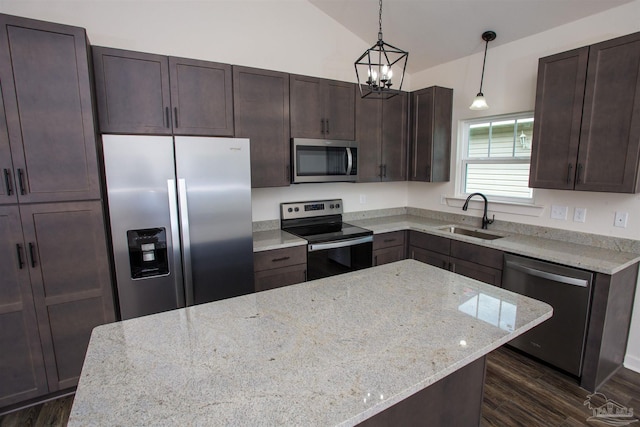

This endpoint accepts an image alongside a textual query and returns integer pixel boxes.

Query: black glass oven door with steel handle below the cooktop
[307,235,373,280]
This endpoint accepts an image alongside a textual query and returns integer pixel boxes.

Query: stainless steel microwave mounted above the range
[291,138,358,184]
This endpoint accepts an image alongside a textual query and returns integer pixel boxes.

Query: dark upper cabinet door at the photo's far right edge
[575,33,640,193]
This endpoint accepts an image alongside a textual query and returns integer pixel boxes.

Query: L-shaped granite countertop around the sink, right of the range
[347,215,640,274]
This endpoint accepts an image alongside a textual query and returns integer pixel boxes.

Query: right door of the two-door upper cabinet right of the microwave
[380,92,409,181]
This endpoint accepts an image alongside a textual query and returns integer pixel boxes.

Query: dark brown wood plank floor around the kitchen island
[0,347,640,427]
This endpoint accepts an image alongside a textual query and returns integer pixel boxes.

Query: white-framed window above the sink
[460,113,533,202]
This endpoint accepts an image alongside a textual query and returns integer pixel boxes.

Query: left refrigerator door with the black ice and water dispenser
[102,135,184,319]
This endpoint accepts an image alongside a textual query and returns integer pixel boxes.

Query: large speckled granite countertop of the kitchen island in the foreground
[69,260,552,426]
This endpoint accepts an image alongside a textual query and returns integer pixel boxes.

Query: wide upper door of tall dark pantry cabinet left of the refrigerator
[0,15,100,202]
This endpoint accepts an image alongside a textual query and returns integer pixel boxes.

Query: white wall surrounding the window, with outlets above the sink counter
[408,0,640,372]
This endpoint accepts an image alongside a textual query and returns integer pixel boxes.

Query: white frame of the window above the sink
[457,111,534,204]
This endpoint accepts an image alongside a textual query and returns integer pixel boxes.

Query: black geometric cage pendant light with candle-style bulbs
[354,0,409,99]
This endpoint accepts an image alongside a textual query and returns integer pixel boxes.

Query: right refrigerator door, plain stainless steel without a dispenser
[175,136,254,305]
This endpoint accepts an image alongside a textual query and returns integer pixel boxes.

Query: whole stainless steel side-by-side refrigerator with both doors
[102,135,254,319]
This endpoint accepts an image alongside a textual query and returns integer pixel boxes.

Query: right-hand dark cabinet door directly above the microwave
[324,80,356,141]
